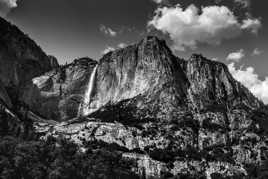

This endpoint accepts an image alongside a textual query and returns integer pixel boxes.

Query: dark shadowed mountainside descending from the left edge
[0,17,58,141]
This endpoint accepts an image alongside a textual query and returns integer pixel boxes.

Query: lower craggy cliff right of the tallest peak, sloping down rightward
[181,54,261,110]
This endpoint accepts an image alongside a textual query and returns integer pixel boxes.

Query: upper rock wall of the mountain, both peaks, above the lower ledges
[21,36,261,121]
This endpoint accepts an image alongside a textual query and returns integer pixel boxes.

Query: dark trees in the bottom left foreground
[0,136,137,179]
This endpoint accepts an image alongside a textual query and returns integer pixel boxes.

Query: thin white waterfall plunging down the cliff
[81,65,98,116]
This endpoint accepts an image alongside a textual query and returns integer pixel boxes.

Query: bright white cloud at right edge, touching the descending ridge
[228,62,268,104]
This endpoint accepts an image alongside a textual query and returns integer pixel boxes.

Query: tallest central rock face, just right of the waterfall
[89,37,188,118]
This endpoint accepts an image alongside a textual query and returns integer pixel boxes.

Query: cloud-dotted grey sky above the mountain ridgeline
[0,0,268,103]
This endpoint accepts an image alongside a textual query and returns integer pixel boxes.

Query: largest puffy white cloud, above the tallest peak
[148,4,261,50]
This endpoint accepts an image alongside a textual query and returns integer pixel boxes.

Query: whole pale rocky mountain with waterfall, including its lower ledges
[23,37,268,178]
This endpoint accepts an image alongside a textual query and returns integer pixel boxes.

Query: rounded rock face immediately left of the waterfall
[21,58,97,121]
